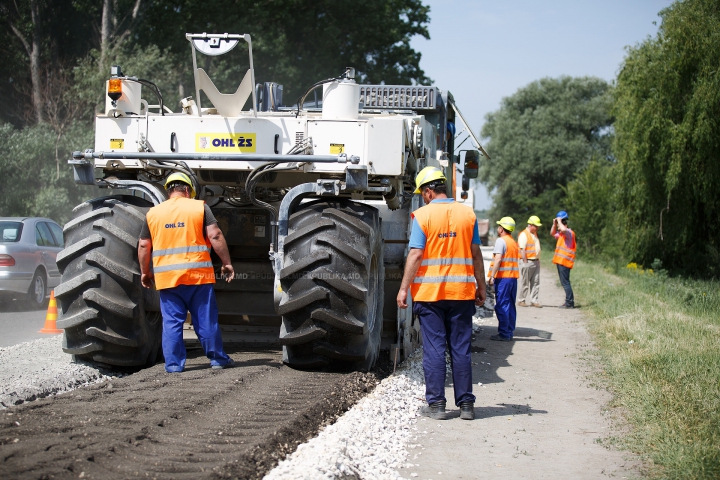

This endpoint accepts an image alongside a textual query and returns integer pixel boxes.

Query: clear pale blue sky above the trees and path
[411,0,673,210]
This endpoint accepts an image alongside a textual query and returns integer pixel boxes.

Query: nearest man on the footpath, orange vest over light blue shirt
[397,167,485,420]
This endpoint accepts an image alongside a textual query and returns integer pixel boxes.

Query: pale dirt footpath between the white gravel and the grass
[402,268,640,480]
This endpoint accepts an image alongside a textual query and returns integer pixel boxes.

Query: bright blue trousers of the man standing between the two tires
[160,284,230,373]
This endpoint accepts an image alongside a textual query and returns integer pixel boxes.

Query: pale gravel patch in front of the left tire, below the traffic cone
[0,335,123,409]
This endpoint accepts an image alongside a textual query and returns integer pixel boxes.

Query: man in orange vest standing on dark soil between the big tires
[138,172,235,373]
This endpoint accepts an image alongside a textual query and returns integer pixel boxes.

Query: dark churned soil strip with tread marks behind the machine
[0,346,378,479]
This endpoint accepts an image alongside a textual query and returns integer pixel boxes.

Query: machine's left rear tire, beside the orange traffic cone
[55,195,162,367]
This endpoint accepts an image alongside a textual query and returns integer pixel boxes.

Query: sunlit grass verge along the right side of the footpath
[571,262,720,479]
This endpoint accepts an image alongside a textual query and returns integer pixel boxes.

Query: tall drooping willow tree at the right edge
[615,0,720,275]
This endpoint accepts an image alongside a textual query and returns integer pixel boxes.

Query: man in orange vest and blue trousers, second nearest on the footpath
[490,217,520,342]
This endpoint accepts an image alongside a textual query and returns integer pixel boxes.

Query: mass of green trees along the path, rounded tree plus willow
[479,0,720,278]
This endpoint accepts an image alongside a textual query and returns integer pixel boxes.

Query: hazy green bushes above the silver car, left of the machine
[0,123,98,225]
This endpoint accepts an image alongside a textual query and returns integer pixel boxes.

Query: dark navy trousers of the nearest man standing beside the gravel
[413,300,475,405]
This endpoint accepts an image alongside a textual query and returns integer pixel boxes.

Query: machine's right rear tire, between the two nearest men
[278,201,384,370]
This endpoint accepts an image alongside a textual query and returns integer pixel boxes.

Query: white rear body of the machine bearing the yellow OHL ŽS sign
[95,106,439,176]
